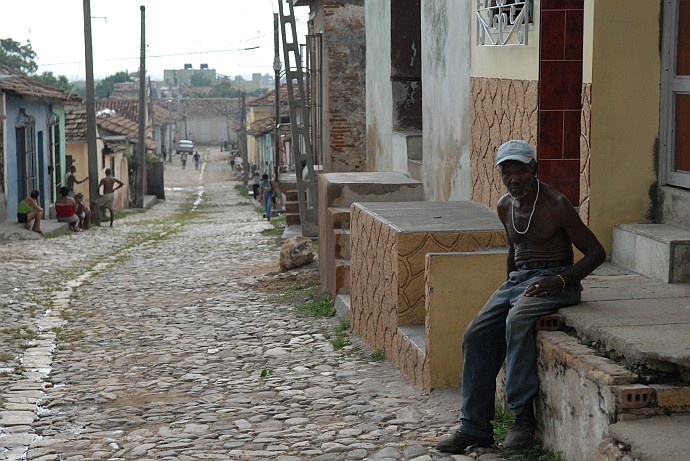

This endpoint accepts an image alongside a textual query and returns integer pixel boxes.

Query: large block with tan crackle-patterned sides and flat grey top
[350,202,507,386]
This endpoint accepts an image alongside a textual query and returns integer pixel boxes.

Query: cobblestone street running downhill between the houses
[0,148,496,461]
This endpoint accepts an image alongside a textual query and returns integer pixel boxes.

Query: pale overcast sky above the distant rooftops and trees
[0,0,309,80]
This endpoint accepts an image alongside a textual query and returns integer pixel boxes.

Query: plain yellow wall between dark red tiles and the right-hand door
[585,0,661,252]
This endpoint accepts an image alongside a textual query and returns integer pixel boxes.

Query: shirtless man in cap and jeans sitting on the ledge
[436,140,606,453]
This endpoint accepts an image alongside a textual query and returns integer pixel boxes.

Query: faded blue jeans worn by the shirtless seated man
[460,266,580,437]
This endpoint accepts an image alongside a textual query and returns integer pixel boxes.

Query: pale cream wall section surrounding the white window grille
[470,0,541,80]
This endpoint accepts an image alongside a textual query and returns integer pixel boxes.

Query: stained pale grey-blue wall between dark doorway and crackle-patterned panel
[422,0,472,200]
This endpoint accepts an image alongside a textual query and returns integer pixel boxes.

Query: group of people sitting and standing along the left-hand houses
[17,166,125,235]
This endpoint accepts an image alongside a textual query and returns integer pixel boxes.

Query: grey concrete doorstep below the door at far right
[611,224,690,283]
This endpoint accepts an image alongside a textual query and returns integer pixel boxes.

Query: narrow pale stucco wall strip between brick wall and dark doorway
[365,0,393,171]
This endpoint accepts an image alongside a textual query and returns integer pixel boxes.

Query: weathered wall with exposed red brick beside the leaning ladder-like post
[322,0,366,172]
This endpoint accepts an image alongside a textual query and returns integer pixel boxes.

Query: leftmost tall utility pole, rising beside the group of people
[84,0,101,226]
